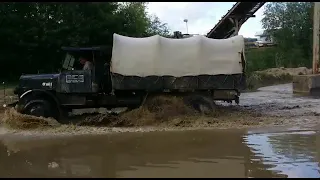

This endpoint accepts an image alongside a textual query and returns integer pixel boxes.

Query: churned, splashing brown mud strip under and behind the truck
[1,84,320,134]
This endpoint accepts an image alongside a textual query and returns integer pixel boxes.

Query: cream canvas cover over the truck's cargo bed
[111,34,244,88]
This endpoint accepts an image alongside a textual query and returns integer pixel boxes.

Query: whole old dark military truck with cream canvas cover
[9,34,245,120]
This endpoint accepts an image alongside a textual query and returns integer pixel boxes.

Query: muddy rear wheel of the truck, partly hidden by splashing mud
[184,95,215,114]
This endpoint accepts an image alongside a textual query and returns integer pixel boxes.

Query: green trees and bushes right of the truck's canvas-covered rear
[247,2,313,71]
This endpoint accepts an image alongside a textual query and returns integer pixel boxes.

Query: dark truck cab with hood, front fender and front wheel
[14,47,138,122]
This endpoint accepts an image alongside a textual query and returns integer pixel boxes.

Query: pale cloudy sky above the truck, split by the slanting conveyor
[147,2,264,38]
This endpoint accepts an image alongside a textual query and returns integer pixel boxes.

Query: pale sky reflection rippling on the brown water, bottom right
[246,131,320,178]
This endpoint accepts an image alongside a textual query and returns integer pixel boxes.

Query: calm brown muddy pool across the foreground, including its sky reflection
[0,130,320,177]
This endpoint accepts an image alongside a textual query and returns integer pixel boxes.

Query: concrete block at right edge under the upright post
[292,74,320,96]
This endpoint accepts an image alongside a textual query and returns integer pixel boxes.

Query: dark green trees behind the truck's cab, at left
[0,2,168,80]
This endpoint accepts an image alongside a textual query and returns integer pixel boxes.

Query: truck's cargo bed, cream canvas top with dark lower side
[110,34,246,91]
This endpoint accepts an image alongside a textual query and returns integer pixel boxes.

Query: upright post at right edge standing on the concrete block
[312,2,320,74]
